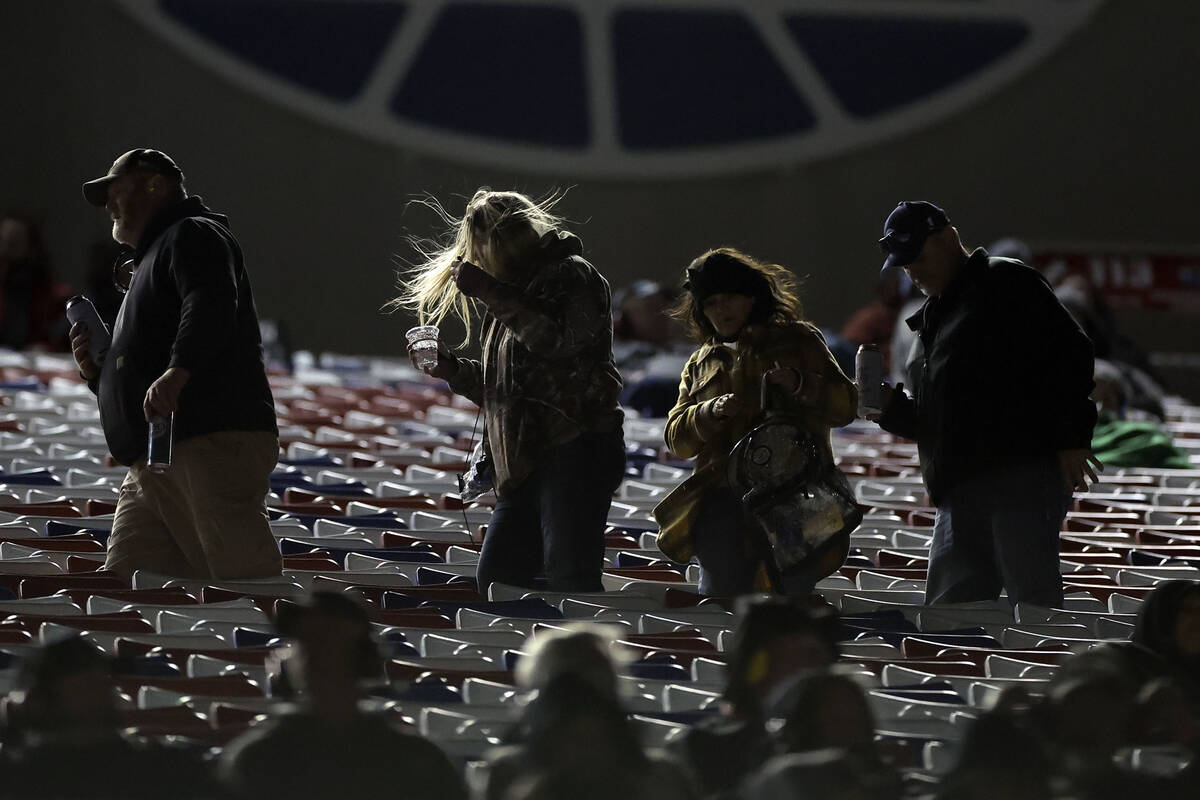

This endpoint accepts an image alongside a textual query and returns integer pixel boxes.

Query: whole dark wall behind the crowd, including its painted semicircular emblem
[0,0,1200,393]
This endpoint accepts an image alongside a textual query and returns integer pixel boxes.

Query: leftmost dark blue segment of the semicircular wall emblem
[160,0,404,100]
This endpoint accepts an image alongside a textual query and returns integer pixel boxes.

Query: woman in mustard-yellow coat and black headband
[654,247,858,596]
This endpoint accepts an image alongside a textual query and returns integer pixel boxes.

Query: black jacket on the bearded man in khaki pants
[91,197,278,464]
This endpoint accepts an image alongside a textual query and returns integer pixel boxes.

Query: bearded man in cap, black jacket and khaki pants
[71,150,281,578]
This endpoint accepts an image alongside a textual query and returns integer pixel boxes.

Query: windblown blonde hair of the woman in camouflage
[388,187,565,339]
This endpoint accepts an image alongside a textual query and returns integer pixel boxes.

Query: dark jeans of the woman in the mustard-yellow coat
[691,488,818,597]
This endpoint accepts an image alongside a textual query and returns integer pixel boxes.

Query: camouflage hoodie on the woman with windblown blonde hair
[450,231,624,494]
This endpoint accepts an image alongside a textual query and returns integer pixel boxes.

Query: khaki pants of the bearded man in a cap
[104,431,283,579]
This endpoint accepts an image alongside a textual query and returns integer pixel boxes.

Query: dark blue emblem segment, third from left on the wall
[613,11,814,150]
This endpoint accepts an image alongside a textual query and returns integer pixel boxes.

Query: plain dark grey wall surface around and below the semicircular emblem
[0,0,1200,383]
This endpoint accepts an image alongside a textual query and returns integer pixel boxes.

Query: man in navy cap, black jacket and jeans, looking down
[878,201,1099,606]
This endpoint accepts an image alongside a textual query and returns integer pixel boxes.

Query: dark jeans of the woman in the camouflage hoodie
[476,429,625,591]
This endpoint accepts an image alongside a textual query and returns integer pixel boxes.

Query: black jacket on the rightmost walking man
[880,248,1096,505]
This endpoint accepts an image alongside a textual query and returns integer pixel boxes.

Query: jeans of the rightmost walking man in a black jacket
[925,456,1072,607]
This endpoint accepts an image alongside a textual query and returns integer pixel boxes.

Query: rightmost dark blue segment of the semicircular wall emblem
[787,14,1030,118]
